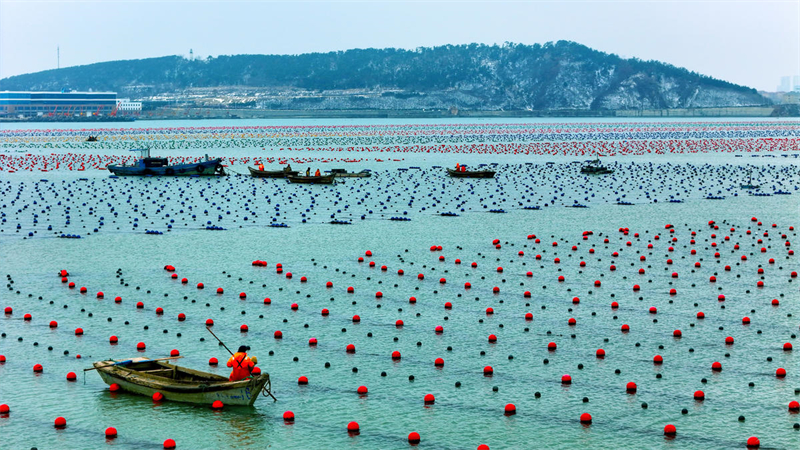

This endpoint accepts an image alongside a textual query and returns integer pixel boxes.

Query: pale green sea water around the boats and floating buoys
[0,121,800,449]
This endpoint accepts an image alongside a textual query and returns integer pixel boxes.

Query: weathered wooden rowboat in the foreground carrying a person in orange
[92,358,272,406]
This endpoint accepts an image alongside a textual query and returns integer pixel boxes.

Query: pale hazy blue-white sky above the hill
[0,0,800,91]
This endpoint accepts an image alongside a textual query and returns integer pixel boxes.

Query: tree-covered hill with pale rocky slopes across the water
[0,41,769,110]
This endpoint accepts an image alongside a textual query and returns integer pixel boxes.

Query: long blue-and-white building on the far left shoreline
[0,90,117,117]
